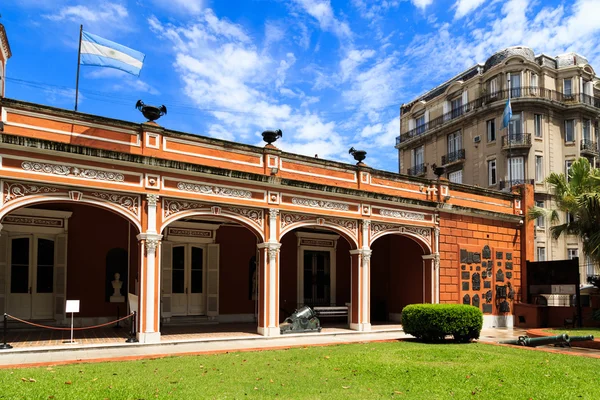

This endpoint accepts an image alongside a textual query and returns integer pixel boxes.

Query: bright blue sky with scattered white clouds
[0,0,600,171]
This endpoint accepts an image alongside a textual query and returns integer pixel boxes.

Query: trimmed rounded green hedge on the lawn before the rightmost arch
[402,304,483,343]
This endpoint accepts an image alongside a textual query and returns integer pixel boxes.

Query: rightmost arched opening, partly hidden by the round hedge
[370,234,432,324]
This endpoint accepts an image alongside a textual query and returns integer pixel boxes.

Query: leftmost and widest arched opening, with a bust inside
[0,199,139,326]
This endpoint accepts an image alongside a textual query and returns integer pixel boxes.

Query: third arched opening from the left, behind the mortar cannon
[279,224,357,328]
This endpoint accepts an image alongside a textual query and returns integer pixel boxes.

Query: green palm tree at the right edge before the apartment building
[527,157,600,264]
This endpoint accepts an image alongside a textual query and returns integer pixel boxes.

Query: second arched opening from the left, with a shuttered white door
[160,211,263,337]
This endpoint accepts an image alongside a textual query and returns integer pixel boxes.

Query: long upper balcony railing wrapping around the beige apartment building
[396,86,600,146]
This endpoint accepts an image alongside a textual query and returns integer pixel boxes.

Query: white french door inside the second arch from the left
[171,244,206,316]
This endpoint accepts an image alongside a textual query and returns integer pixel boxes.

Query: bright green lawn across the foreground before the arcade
[0,342,600,400]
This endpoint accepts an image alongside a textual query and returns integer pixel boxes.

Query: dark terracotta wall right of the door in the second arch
[217,226,257,314]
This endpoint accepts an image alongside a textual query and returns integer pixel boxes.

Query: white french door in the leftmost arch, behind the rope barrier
[7,235,56,319]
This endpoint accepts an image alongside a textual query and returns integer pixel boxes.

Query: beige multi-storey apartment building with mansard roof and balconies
[396,46,600,281]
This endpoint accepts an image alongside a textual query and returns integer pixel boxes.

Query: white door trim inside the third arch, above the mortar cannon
[296,232,340,305]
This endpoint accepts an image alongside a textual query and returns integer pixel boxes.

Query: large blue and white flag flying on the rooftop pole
[81,32,146,76]
